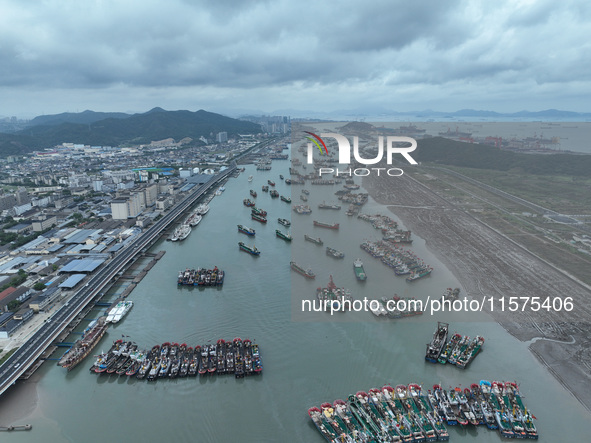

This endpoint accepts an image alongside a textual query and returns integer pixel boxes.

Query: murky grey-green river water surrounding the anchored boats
[2,152,589,443]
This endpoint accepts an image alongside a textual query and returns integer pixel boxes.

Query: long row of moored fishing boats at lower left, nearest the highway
[90,338,263,381]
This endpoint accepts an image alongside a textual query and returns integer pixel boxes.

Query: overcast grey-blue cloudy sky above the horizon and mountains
[0,0,591,118]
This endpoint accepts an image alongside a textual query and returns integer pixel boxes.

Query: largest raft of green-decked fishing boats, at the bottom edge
[308,380,538,443]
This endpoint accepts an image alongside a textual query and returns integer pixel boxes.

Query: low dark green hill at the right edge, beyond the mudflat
[412,137,591,178]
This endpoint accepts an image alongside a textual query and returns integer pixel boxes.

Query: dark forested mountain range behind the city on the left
[0,108,261,157]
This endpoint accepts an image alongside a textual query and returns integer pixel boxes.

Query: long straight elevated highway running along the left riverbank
[0,163,236,395]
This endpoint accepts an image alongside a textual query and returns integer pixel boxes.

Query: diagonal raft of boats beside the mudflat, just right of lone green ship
[360,240,433,282]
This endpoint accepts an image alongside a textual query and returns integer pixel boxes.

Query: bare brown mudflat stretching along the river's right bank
[364,175,591,410]
